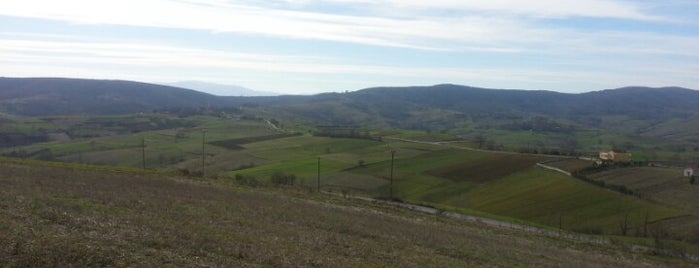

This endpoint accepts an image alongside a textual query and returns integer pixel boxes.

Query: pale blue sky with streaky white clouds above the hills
[0,0,699,94]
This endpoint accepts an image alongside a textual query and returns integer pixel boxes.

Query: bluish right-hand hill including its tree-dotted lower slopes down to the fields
[262,85,699,159]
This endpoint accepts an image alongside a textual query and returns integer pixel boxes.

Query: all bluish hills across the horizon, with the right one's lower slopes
[0,78,699,159]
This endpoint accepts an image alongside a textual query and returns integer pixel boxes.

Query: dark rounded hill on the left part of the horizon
[0,78,225,116]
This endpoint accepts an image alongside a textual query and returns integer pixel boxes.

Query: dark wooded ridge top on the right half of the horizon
[272,85,699,127]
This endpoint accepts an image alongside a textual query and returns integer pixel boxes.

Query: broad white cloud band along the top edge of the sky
[0,0,672,51]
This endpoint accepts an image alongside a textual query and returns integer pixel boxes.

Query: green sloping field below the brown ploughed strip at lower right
[465,168,683,233]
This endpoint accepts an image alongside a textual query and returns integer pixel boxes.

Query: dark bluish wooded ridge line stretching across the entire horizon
[0,78,699,127]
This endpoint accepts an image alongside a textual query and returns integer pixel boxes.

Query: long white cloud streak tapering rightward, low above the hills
[0,36,600,90]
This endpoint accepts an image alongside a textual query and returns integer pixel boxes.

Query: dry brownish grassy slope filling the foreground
[0,158,693,267]
